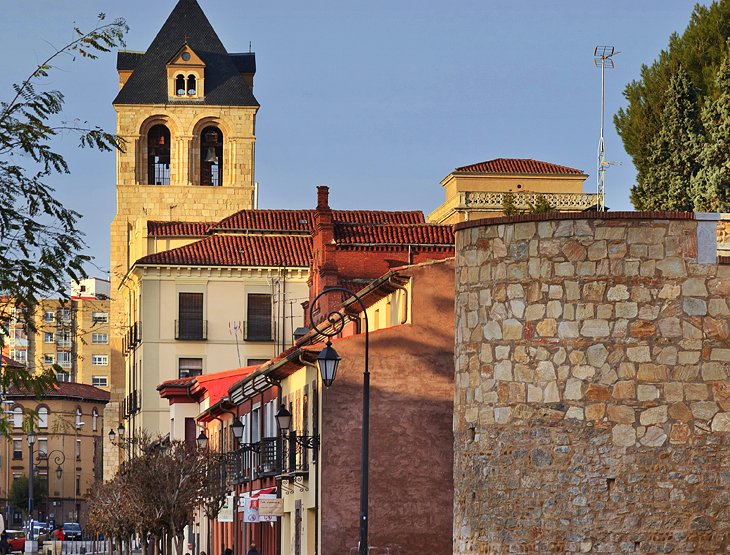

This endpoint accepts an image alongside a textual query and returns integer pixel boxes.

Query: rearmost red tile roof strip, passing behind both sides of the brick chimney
[210,210,426,233]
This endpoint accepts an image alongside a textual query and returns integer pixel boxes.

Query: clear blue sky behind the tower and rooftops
[0,0,706,275]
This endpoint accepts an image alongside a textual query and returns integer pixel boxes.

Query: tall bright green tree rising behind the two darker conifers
[614,0,730,186]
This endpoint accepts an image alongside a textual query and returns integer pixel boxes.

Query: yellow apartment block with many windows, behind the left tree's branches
[5,278,110,388]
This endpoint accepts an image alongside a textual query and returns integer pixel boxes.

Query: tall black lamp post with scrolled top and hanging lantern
[309,287,370,555]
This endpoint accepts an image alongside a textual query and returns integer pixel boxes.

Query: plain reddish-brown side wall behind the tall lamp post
[321,261,454,554]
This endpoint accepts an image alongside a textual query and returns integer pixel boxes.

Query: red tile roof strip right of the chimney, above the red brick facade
[335,224,454,247]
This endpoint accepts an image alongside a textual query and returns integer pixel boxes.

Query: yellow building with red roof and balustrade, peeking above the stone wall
[428,158,598,224]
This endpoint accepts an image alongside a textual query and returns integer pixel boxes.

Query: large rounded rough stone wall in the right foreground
[454,213,730,554]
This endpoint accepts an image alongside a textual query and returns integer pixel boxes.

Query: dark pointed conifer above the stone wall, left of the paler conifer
[631,68,703,210]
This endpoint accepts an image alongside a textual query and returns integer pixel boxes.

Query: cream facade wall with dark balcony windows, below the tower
[124,267,309,435]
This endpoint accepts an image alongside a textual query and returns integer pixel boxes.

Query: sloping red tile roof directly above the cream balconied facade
[136,235,312,268]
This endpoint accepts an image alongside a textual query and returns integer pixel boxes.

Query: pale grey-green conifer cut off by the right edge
[691,58,730,212]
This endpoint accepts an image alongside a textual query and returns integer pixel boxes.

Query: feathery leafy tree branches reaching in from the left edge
[0,14,127,416]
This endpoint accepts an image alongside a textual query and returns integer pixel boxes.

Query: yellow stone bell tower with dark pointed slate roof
[105,0,259,474]
